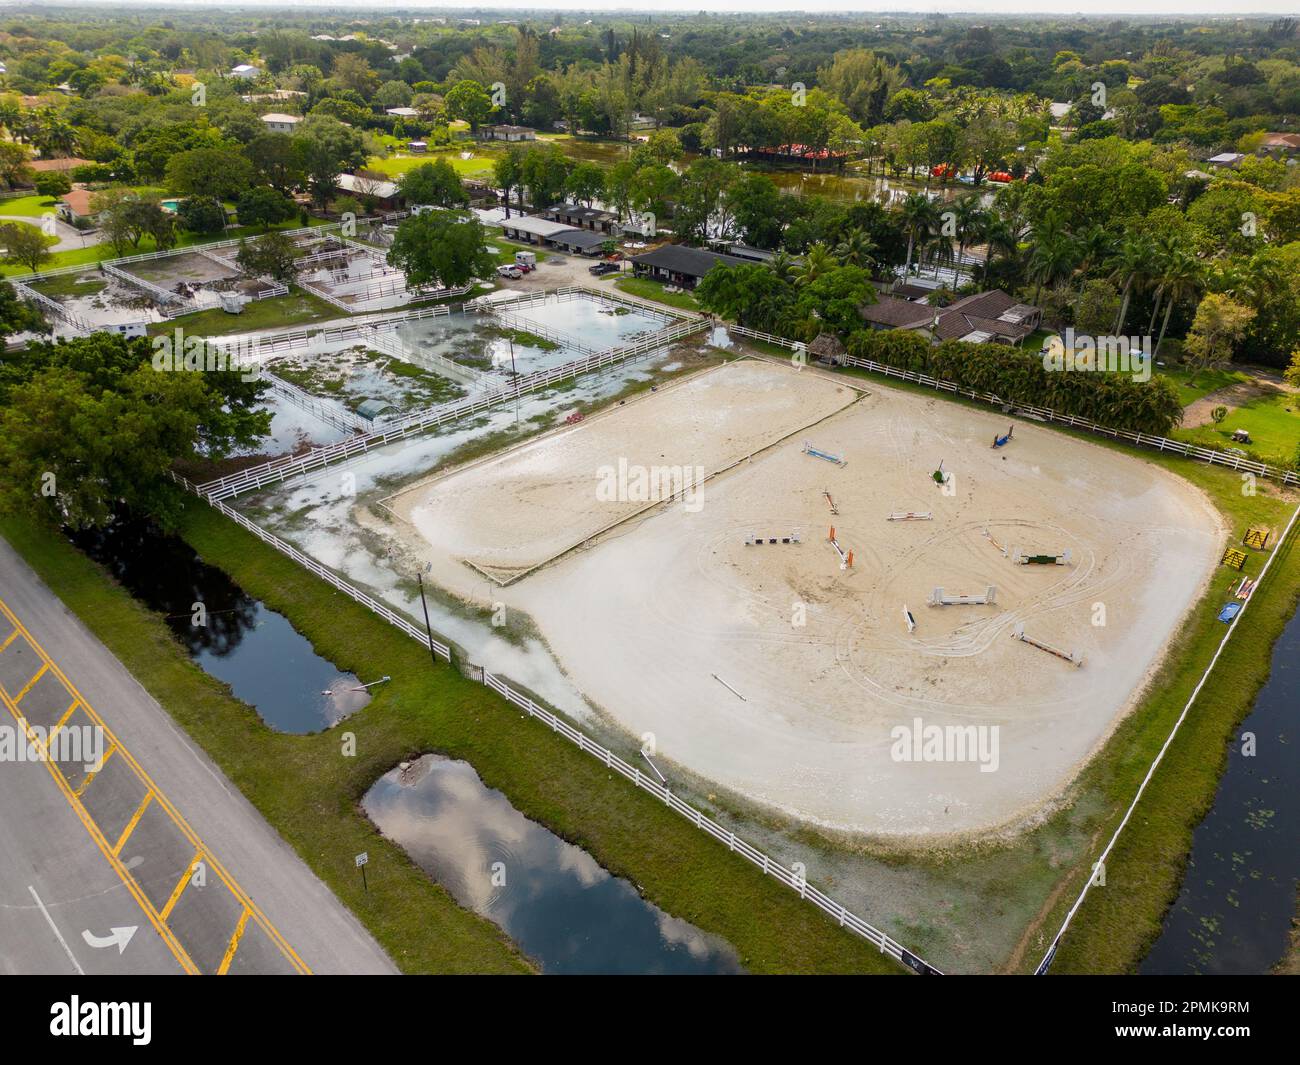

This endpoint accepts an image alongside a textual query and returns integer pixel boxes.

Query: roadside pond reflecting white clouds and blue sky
[363,754,741,974]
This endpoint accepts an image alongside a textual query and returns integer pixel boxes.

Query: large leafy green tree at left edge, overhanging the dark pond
[0,333,270,528]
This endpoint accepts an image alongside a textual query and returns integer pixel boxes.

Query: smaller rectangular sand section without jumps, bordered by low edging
[384,360,859,585]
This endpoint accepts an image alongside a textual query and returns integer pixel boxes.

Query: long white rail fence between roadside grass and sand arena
[173,475,943,977]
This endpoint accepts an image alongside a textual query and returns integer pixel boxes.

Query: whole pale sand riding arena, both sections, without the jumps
[371,363,1223,837]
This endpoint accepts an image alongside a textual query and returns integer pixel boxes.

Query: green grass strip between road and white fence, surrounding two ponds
[0,501,900,973]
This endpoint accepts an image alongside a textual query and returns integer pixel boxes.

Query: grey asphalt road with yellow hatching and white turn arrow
[0,540,397,974]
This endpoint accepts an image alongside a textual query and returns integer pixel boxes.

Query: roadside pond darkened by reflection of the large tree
[69,519,371,732]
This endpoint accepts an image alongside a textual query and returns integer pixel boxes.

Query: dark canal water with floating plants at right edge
[1139,603,1300,975]
